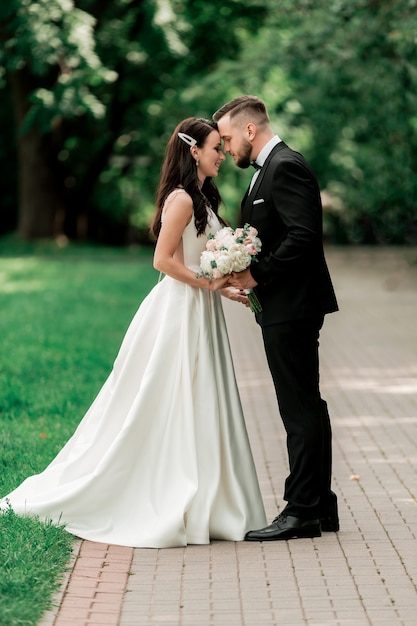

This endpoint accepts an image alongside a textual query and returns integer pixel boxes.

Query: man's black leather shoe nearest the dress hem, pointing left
[245,513,321,541]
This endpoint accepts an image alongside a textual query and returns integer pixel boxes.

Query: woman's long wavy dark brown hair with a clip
[151,117,223,237]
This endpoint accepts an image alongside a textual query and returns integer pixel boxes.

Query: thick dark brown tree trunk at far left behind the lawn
[9,70,64,240]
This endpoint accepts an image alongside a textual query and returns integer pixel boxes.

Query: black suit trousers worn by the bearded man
[262,317,337,519]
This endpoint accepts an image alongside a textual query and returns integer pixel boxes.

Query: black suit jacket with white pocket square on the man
[242,142,338,326]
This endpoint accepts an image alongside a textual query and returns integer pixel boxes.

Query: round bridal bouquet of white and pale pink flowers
[197,224,262,313]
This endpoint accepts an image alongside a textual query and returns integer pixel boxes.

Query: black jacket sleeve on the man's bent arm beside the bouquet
[251,159,322,284]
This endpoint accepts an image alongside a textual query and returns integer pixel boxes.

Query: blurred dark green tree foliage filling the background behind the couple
[0,0,417,243]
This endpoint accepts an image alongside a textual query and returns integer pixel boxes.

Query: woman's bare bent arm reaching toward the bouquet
[153,193,229,291]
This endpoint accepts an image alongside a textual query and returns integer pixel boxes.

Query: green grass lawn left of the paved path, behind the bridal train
[0,241,158,626]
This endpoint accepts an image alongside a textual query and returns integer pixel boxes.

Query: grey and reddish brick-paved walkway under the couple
[41,249,417,626]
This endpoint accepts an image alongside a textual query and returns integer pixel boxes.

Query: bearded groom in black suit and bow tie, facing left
[213,96,339,541]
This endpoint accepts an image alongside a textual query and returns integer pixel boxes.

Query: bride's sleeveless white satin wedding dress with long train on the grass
[0,194,266,548]
